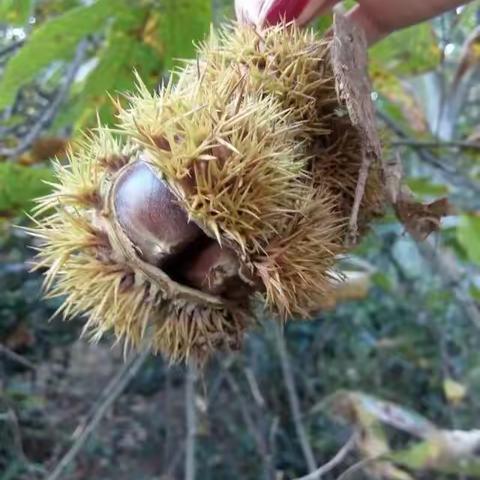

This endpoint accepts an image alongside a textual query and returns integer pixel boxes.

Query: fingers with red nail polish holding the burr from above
[235,0,468,44]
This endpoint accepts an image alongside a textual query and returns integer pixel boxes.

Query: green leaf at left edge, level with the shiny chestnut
[0,163,54,217]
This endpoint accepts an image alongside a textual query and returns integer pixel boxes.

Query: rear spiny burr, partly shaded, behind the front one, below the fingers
[179,24,384,230]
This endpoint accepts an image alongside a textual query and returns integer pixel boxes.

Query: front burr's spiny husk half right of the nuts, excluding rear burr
[116,68,346,317]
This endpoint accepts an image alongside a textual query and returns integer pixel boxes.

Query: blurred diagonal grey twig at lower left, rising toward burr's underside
[46,349,149,480]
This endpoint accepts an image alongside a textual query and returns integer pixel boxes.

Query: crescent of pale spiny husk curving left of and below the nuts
[29,128,248,361]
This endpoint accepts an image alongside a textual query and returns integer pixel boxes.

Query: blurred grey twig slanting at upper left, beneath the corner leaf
[0,39,89,158]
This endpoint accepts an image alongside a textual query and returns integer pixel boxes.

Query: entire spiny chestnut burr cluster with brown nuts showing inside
[32,19,382,360]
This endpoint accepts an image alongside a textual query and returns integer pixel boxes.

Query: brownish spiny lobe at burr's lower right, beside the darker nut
[255,192,345,320]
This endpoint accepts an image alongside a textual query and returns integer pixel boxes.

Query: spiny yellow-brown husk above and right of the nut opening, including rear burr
[121,25,368,317]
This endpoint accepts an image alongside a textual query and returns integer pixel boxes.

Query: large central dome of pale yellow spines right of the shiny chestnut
[120,78,308,254]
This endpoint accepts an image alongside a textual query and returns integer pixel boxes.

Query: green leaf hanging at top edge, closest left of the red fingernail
[158,0,212,69]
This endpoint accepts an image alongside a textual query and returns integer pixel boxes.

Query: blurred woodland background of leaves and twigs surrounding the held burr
[0,0,480,480]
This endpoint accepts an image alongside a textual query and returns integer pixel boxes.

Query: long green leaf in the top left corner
[0,0,123,110]
